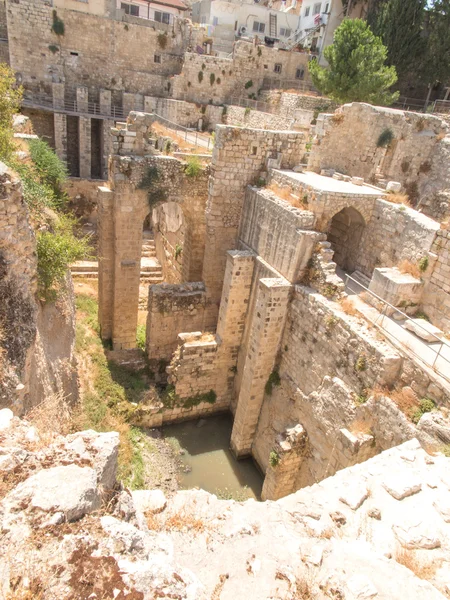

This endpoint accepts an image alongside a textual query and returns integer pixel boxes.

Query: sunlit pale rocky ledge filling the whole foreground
[0,409,450,600]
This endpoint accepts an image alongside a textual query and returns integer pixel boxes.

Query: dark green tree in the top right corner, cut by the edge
[422,0,450,89]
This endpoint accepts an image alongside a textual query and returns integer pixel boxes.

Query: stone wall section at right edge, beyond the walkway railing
[422,229,450,333]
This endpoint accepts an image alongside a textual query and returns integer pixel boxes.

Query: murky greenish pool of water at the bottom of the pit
[163,415,263,500]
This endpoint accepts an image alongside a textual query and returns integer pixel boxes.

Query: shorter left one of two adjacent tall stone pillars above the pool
[216,250,255,402]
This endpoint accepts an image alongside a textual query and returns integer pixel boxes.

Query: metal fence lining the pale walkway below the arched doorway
[345,274,450,382]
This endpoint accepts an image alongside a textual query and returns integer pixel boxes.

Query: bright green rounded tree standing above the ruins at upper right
[309,19,398,105]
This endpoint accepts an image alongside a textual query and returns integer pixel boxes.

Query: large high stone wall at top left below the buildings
[7,0,203,101]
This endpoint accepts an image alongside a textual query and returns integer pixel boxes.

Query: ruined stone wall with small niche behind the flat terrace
[308,103,450,213]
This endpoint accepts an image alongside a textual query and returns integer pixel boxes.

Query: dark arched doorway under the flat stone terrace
[328,206,366,273]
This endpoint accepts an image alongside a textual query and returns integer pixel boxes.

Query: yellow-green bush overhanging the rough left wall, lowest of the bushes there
[36,215,89,300]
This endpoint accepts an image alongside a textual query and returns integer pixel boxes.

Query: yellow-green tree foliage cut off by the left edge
[0,63,22,160]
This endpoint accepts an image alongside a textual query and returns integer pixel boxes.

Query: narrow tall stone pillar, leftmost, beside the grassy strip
[97,186,114,340]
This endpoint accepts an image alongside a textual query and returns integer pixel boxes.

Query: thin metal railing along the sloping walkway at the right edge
[344,274,450,382]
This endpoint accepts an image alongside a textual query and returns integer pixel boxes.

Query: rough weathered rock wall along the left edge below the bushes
[0,163,77,414]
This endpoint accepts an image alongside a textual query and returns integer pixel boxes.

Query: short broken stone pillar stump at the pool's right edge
[261,424,307,500]
